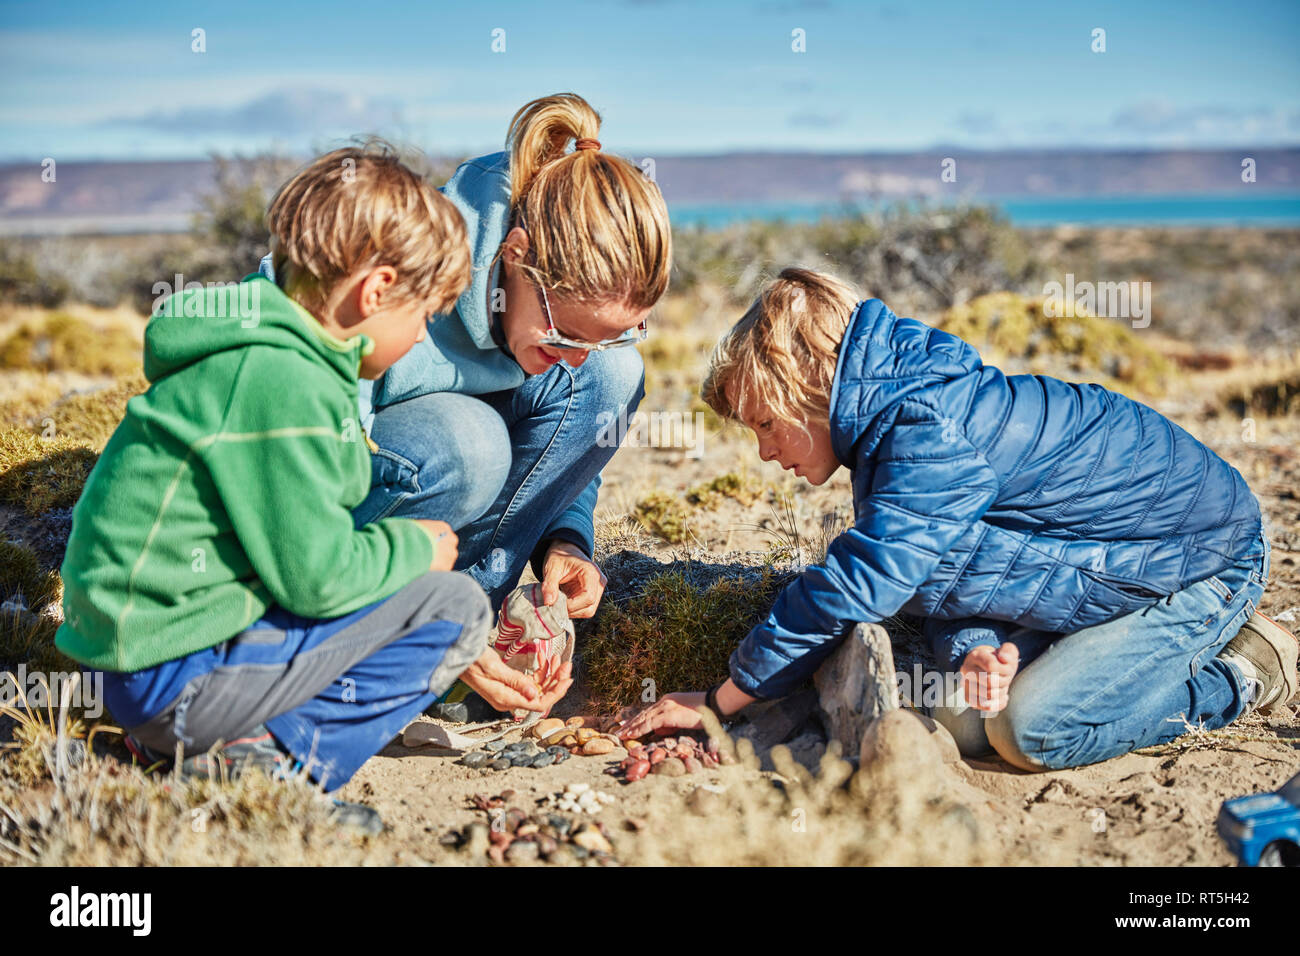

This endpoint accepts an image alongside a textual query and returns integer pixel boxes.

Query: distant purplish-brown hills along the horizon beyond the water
[0,148,1300,235]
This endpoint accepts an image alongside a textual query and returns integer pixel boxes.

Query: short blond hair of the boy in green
[267,139,471,312]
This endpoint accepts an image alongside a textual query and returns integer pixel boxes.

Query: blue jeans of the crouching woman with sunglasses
[352,347,645,609]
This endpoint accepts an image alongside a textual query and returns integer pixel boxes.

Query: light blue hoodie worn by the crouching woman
[261,152,601,554]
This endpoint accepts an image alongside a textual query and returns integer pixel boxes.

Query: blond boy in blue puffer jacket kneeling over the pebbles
[620,269,1300,770]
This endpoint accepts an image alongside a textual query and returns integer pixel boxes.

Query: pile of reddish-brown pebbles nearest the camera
[442,790,618,865]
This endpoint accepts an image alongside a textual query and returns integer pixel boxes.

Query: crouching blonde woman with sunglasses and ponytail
[261,94,671,634]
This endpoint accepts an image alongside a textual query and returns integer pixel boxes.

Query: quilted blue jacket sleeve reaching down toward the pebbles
[731,401,998,698]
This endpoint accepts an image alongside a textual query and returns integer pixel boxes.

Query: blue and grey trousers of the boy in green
[104,571,491,791]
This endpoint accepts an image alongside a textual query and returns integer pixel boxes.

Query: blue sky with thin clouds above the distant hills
[0,0,1300,160]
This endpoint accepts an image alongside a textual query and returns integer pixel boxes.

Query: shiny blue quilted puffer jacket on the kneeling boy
[731,299,1264,698]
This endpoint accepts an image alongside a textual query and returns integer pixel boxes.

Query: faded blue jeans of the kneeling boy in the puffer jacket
[927,540,1269,770]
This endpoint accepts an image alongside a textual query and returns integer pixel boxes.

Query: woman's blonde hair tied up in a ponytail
[497,92,672,310]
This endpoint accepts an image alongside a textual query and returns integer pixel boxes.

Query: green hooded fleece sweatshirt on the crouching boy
[55,276,433,671]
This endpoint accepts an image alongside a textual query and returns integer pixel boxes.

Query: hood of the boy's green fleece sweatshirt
[144,273,374,382]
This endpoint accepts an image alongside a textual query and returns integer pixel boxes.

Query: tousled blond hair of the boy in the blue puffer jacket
[699,269,861,424]
